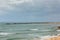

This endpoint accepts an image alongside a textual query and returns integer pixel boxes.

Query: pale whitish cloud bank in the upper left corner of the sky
[0,0,31,15]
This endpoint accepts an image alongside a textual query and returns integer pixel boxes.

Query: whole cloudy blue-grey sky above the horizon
[0,0,60,22]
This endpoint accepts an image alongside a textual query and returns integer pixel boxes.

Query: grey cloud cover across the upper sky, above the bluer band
[0,0,60,16]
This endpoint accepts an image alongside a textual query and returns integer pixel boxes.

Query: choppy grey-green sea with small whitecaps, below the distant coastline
[0,24,60,40]
